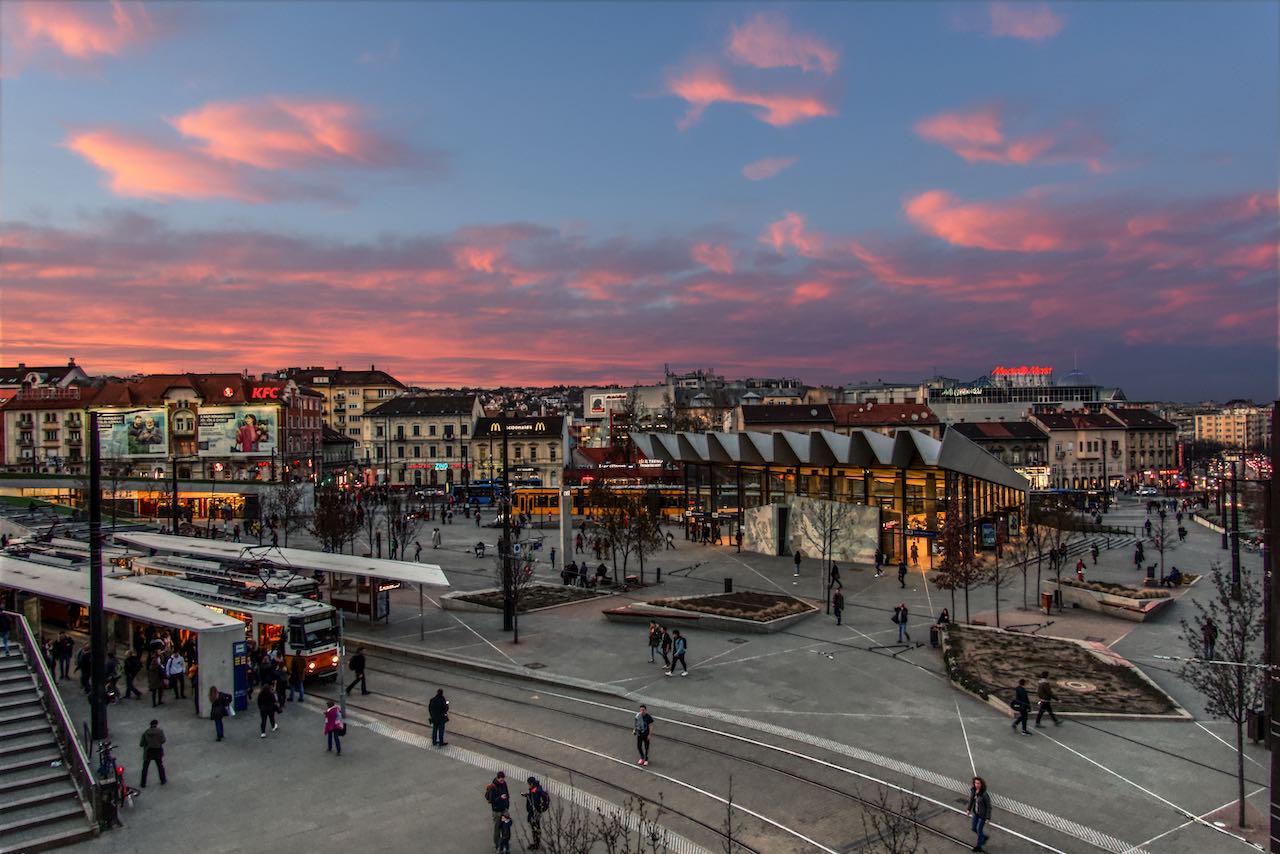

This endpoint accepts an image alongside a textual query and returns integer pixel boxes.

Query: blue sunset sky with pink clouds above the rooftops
[0,0,1280,401]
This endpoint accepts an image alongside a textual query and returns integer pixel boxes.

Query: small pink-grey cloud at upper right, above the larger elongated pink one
[915,105,1107,173]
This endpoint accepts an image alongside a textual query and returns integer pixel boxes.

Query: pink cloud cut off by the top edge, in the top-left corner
[13,0,155,60]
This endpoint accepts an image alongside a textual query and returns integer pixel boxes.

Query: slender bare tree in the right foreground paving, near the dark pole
[1180,563,1266,827]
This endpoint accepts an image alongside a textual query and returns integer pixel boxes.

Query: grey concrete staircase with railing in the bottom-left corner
[0,624,97,854]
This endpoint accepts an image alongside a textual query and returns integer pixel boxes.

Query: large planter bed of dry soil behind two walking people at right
[942,625,1190,720]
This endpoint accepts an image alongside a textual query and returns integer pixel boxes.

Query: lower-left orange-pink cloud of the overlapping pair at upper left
[67,129,269,202]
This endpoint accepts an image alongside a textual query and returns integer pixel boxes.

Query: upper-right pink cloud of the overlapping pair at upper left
[172,96,406,169]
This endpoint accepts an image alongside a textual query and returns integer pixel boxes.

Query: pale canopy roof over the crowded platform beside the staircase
[0,554,244,632]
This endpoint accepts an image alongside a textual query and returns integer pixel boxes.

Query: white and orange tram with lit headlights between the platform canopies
[137,575,340,679]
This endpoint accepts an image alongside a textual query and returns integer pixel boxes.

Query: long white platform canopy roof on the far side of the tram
[115,531,449,588]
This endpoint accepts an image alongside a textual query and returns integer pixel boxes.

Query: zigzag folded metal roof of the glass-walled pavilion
[631,428,1030,492]
